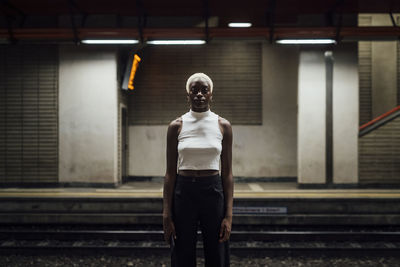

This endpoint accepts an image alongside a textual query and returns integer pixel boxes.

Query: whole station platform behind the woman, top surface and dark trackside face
[0,180,400,227]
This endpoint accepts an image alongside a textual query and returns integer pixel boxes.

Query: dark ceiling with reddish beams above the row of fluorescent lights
[0,0,400,42]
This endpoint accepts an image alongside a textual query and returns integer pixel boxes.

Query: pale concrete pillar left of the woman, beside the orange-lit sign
[59,46,118,184]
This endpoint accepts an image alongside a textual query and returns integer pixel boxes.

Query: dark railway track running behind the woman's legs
[0,229,400,255]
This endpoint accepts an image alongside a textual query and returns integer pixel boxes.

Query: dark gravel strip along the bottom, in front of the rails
[0,255,400,267]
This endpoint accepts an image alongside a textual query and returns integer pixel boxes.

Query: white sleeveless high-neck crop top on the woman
[178,110,222,170]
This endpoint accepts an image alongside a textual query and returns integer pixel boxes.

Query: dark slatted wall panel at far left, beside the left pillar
[0,45,58,183]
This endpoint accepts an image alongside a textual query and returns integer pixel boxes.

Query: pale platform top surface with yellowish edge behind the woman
[0,180,400,198]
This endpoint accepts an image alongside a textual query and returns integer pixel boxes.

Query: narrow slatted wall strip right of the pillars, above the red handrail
[358,15,372,125]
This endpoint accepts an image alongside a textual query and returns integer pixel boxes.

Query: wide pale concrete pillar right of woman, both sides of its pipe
[298,44,359,184]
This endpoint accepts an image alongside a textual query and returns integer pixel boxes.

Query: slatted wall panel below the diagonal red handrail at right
[359,117,400,183]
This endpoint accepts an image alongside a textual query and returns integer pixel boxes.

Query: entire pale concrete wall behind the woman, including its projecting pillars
[55,44,358,183]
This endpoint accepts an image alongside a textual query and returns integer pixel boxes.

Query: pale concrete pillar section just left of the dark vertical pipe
[297,49,326,184]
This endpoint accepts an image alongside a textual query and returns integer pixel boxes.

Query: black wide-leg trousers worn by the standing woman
[171,175,229,267]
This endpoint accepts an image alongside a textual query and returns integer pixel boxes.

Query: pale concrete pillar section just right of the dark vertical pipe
[332,43,359,184]
